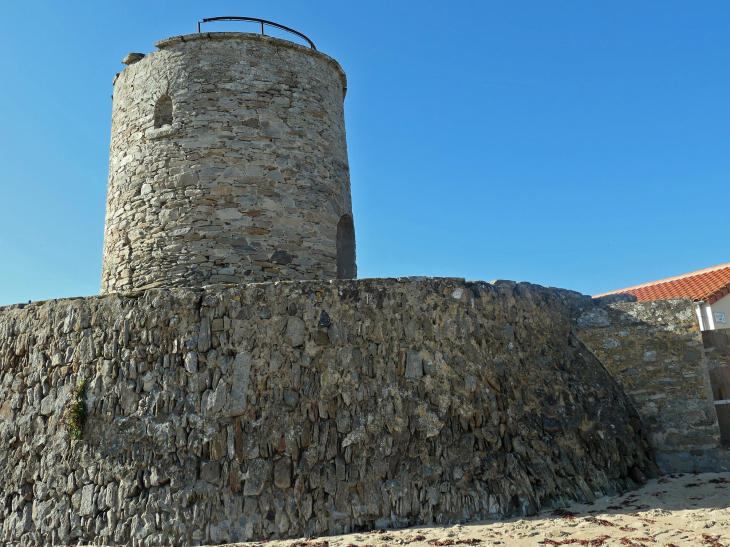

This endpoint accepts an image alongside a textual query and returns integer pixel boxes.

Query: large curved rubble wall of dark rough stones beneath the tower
[0,278,658,545]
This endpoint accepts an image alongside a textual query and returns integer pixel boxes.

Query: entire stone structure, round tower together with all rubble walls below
[8,23,730,547]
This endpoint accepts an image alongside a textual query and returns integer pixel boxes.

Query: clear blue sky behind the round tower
[0,0,730,305]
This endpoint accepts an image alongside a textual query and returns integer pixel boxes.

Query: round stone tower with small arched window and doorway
[101,32,357,293]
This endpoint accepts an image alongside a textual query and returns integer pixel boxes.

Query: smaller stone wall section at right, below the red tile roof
[576,295,730,472]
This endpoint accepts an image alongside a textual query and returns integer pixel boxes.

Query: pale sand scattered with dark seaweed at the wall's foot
[229,473,730,547]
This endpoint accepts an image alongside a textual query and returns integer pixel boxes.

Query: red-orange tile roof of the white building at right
[594,264,730,304]
